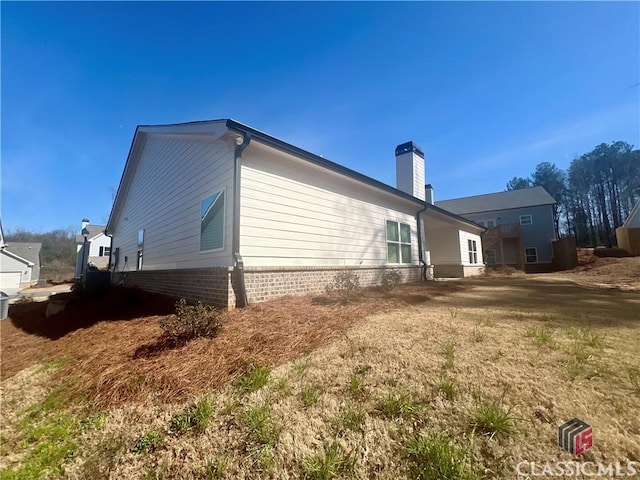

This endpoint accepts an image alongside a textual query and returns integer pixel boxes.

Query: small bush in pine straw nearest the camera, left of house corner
[160,298,222,344]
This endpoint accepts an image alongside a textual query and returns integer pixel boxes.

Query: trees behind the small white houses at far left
[4,228,76,268]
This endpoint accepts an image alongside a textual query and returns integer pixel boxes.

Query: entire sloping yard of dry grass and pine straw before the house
[0,259,640,479]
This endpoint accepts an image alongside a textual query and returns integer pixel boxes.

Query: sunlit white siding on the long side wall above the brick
[240,142,419,267]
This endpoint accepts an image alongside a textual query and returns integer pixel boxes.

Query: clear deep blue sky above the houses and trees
[0,1,640,231]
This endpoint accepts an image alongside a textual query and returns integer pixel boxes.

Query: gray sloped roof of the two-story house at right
[436,186,556,215]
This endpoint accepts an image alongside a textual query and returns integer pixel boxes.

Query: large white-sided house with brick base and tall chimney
[106,120,485,308]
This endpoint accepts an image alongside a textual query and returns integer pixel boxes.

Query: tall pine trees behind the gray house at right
[507,141,640,247]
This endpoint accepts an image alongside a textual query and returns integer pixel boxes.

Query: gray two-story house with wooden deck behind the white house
[436,186,556,272]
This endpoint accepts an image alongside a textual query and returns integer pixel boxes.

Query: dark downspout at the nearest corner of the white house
[231,132,251,308]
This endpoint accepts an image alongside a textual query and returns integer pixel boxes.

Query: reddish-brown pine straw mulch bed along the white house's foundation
[0,282,465,407]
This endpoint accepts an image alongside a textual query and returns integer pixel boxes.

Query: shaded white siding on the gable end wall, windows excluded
[112,133,233,271]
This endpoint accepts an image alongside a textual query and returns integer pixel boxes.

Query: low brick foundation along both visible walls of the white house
[112,265,428,309]
